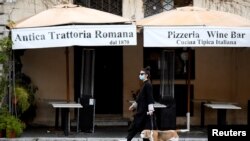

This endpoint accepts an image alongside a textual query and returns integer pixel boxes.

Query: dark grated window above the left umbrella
[74,0,122,16]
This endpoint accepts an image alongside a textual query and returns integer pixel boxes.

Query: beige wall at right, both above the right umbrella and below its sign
[193,0,250,124]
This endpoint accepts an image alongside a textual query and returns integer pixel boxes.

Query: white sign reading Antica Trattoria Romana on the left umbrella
[11,25,137,49]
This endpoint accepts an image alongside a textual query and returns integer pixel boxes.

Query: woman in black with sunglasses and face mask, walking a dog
[127,67,154,141]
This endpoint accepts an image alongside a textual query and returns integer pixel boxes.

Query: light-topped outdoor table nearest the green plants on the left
[50,101,82,136]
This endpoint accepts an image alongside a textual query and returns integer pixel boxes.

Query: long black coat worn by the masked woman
[134,80,154,130]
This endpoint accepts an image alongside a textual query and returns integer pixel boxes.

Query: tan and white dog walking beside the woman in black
[140,130,179,141]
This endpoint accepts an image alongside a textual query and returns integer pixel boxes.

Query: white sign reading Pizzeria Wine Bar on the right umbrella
[144,26,250,47]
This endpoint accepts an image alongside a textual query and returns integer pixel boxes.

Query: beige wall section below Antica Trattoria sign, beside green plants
[22,48,74,125]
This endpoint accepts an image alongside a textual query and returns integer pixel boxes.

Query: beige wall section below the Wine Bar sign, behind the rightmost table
[191,48,247,124]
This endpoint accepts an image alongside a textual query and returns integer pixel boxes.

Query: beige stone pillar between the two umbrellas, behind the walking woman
[122,0,144,118]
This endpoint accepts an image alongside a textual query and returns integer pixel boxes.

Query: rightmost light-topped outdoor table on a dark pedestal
[204,103,241,125]
